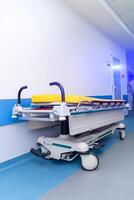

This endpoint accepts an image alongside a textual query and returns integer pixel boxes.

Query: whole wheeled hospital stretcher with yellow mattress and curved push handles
[12,82,126,171]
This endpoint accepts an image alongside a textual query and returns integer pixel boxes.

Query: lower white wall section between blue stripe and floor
[0,123,59,163]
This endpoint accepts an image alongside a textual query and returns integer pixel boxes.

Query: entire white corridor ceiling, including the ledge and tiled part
[64,0,134,50]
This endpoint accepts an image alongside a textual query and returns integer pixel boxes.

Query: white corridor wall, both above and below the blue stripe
[0,0,127,162]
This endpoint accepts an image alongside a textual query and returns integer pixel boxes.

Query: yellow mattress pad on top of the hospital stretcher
[32,94,124,104]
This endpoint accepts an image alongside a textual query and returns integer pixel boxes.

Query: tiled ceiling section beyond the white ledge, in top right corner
[107,0,134,33]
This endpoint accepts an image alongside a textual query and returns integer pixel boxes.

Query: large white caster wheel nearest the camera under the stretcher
[80,154,99,171]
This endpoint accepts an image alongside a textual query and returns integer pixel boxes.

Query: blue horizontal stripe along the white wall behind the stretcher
[0,95,128,126]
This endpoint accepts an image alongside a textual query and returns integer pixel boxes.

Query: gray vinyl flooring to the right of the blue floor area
[40,133,134,200]
